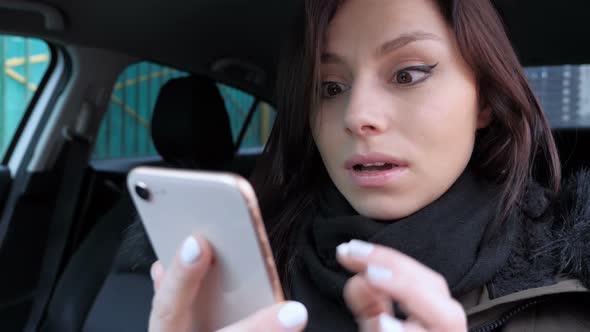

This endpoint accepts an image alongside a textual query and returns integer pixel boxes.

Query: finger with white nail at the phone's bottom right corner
[218,302,307,332]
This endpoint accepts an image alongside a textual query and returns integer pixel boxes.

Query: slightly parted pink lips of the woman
[344,153,408,187]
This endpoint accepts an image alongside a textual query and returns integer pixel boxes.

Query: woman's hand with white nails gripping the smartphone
[149,236,307,332]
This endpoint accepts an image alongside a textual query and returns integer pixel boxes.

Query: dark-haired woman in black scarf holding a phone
[150,0,590,332]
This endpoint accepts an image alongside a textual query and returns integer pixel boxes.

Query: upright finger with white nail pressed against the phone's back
[150,236,213,331]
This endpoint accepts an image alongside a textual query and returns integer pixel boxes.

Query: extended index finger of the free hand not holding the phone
[337,241,467,331]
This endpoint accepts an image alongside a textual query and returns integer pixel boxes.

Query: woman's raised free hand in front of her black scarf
[337,240,467,332]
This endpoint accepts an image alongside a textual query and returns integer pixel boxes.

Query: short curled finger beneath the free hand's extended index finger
[344,275,393,320]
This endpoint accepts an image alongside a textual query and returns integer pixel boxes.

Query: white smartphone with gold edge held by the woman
[127,167,284,332]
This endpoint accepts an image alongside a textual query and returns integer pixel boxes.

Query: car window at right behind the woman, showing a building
[525,65,590,128]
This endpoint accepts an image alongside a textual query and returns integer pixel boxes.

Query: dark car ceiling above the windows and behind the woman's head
[0,0,590,98]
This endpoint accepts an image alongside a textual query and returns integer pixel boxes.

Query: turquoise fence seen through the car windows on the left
[0,35,274,159]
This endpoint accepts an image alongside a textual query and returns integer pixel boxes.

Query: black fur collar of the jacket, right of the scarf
[487,170,590,298]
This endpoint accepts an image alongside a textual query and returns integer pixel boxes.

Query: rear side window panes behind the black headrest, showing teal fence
[93,62,274,160]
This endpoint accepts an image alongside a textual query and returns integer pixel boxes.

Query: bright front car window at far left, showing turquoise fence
[0,35,51,160]
